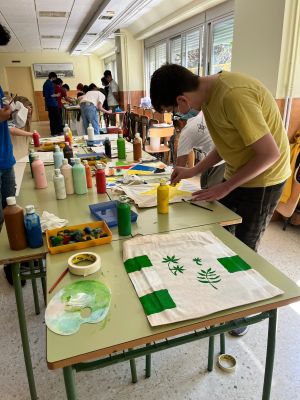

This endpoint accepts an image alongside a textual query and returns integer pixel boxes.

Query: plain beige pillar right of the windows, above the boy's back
[231,0,285,96]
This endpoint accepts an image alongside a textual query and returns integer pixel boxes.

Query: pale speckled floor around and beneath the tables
[0,222,300,400]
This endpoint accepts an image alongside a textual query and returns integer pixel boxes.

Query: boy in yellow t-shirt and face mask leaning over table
[150,64,290,250]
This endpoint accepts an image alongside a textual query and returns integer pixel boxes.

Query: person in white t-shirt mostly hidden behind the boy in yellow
[174,111,225,188]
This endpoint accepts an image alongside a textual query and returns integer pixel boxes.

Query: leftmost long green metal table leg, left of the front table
[11,263,38,400]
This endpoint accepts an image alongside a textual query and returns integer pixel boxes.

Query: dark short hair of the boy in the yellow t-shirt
[150,63,199,113]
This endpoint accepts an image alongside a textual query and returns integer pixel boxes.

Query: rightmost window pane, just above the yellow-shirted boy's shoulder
[209,18,233,74]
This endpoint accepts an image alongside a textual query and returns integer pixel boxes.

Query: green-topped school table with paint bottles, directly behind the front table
[0,163,241,400]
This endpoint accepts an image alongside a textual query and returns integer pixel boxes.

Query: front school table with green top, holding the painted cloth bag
[46,224,300,400]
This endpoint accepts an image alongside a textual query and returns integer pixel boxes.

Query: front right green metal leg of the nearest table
[262,309,277,400]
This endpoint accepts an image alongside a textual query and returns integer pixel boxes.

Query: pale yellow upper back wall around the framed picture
[0,53,104,94]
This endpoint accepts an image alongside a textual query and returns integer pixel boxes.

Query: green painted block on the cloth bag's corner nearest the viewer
[140,289,176,315]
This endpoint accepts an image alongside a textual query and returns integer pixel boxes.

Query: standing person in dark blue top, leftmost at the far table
[43,72,63,136]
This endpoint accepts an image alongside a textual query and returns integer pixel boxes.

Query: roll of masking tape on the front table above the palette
[68,251,101,276]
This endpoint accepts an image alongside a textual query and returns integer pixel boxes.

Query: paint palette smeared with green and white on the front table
[45,280,111,335]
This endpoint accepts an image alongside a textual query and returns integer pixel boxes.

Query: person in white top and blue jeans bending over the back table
[79,83,111,135]
